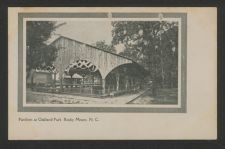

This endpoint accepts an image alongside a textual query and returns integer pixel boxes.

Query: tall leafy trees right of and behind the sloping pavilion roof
[112,21,178,95]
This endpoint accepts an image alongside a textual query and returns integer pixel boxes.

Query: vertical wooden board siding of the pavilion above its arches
[52,37,132,79]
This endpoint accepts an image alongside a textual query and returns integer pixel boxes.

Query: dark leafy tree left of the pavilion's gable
[26,21,57,78]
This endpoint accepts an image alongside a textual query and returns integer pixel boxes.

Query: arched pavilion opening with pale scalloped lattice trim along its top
[63,59,102,95]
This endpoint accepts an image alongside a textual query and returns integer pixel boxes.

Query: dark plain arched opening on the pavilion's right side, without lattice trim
[105,63,148,94]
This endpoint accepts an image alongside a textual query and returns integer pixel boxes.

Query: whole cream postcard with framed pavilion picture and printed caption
[8,7,217,140]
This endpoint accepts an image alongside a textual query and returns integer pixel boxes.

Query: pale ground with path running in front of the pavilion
[26,88,178,105]
